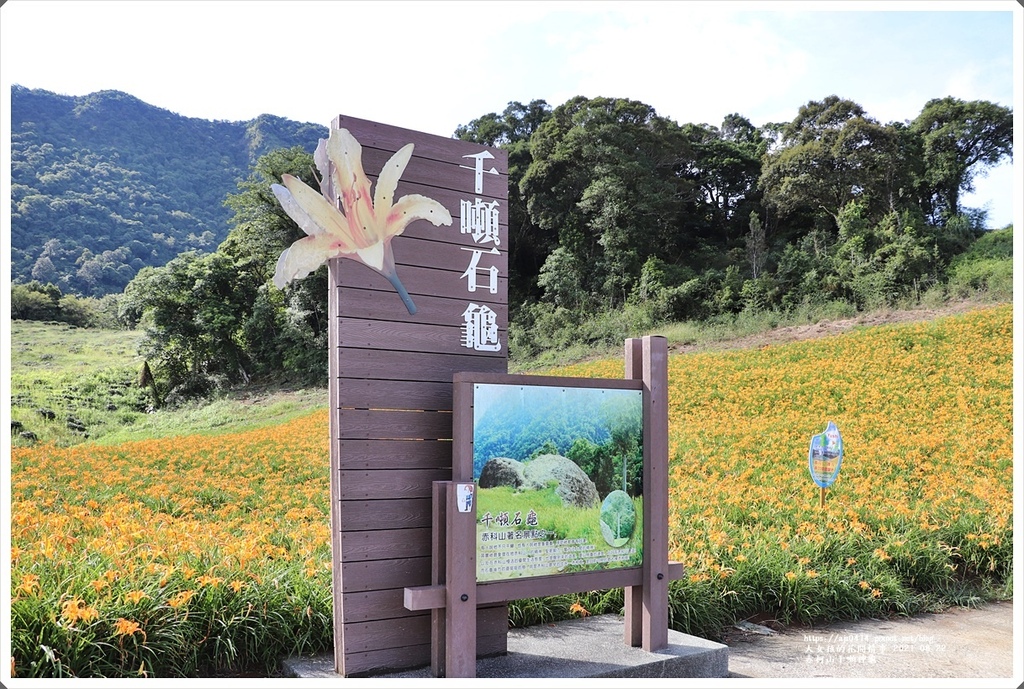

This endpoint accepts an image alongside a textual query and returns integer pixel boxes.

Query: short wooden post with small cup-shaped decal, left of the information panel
[444,481,476,677]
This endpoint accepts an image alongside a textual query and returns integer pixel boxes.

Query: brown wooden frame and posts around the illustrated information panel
[403,336,684,677]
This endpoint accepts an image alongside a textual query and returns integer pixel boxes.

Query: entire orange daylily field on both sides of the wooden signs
[10,304,1014,677]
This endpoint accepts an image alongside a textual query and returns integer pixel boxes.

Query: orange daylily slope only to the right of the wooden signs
[554,304,1013,629]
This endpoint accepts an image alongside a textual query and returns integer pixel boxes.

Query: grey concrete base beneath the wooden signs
[283,615,729,679]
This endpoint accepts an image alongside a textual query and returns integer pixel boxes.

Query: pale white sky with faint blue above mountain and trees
[0,0,1024,227]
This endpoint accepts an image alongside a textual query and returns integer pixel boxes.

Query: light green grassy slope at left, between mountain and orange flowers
[10,320,327,446]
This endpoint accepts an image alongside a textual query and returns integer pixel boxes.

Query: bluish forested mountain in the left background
[10,86,328,296]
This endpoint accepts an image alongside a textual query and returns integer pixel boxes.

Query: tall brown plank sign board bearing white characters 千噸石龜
[329,116,509,676]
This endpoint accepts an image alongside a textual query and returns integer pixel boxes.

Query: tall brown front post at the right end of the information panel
[642,335,669,652]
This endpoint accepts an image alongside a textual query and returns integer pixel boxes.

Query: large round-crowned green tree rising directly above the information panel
[519,96,689,310]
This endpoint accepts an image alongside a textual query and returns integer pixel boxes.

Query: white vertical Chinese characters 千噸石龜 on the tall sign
[459,150,502,352]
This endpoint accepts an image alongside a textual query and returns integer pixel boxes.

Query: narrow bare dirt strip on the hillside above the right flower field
[669,301,996,354]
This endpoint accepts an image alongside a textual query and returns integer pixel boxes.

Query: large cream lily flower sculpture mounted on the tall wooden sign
[270,129,452,313]
